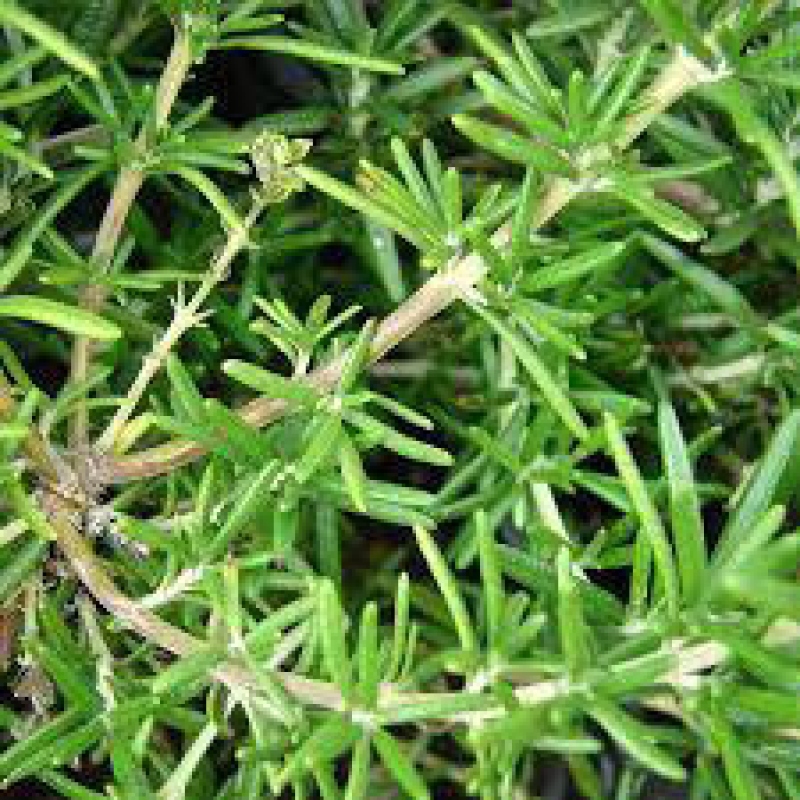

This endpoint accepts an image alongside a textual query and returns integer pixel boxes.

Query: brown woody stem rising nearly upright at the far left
[70,25,192,446]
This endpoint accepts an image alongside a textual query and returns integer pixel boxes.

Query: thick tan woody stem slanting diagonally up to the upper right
[106,48,721,483]
